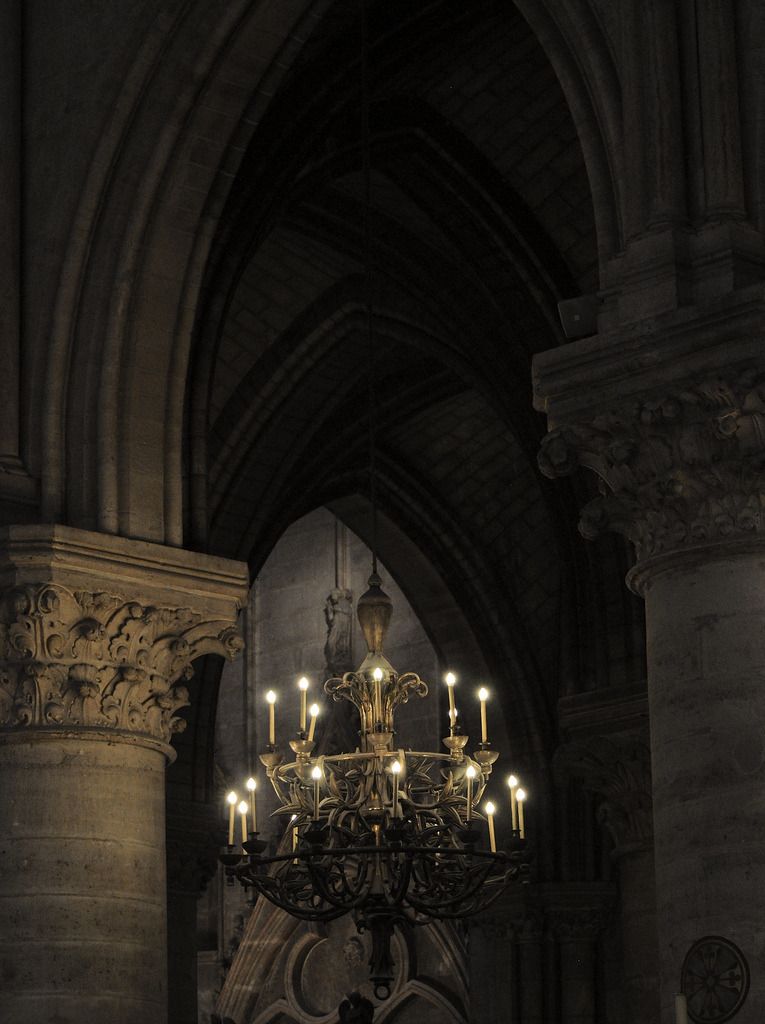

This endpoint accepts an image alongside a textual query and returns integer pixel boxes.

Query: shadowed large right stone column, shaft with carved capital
[537,315,765,1024]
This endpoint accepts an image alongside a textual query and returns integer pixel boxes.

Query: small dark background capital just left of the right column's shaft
[555,734,653,856]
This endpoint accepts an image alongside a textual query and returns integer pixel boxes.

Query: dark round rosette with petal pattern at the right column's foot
[680,935,749,1024]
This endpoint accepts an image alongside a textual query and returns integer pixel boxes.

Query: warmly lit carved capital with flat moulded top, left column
[0,526,247,744]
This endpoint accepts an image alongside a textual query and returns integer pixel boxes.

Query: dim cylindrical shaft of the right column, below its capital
[632,542,765,1024]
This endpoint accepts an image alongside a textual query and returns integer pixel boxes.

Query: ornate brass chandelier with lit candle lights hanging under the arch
[220,568,527,999]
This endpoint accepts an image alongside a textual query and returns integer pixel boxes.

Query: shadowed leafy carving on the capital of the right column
[539,370,765,559]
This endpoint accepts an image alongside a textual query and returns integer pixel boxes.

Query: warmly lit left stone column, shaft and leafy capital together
[0,526,247,1024]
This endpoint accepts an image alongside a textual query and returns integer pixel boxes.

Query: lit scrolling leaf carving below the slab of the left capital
[0,584,243,742]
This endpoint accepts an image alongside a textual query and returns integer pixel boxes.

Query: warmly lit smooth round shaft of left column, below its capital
[0,730,167,1024]
